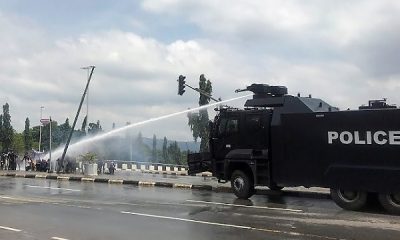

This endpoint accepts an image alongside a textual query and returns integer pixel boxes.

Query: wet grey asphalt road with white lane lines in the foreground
[0,177,400,240]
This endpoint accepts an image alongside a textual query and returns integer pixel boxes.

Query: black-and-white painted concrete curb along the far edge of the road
[0,172,330,199]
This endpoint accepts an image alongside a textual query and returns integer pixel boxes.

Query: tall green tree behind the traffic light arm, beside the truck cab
[188,74,212,152]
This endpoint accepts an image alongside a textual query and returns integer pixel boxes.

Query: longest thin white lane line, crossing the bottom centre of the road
[121,211,346,240]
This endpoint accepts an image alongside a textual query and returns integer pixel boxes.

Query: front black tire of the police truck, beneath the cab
[231,170,255,199]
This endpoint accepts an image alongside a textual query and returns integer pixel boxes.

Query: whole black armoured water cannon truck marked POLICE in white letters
[188,84,400,214]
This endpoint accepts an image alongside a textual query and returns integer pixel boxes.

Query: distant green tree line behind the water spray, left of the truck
[0,103,187,165]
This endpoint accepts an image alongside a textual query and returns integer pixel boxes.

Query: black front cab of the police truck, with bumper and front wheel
[188,108,272,198]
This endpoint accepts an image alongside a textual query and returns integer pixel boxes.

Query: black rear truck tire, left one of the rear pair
[331,188,368,211]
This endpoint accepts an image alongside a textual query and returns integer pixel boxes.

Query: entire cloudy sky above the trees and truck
[0,0,400,140]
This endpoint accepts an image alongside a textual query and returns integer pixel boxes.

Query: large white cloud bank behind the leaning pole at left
[0,11,225,139]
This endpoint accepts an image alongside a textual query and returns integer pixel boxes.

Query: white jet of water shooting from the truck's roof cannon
[45,94,253,162]
